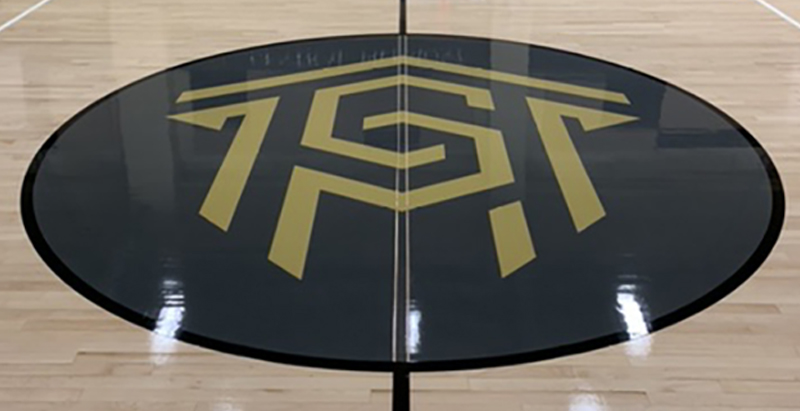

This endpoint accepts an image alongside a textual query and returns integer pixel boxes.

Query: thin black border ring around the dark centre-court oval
[20,33,786,372]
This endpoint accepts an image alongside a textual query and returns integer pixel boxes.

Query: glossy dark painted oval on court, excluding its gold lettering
[22,35,784,371]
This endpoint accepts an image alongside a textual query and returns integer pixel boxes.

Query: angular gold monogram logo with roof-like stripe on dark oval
[169,56,636,279]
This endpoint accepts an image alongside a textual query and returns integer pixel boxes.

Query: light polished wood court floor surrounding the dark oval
[0,0,800,411]
